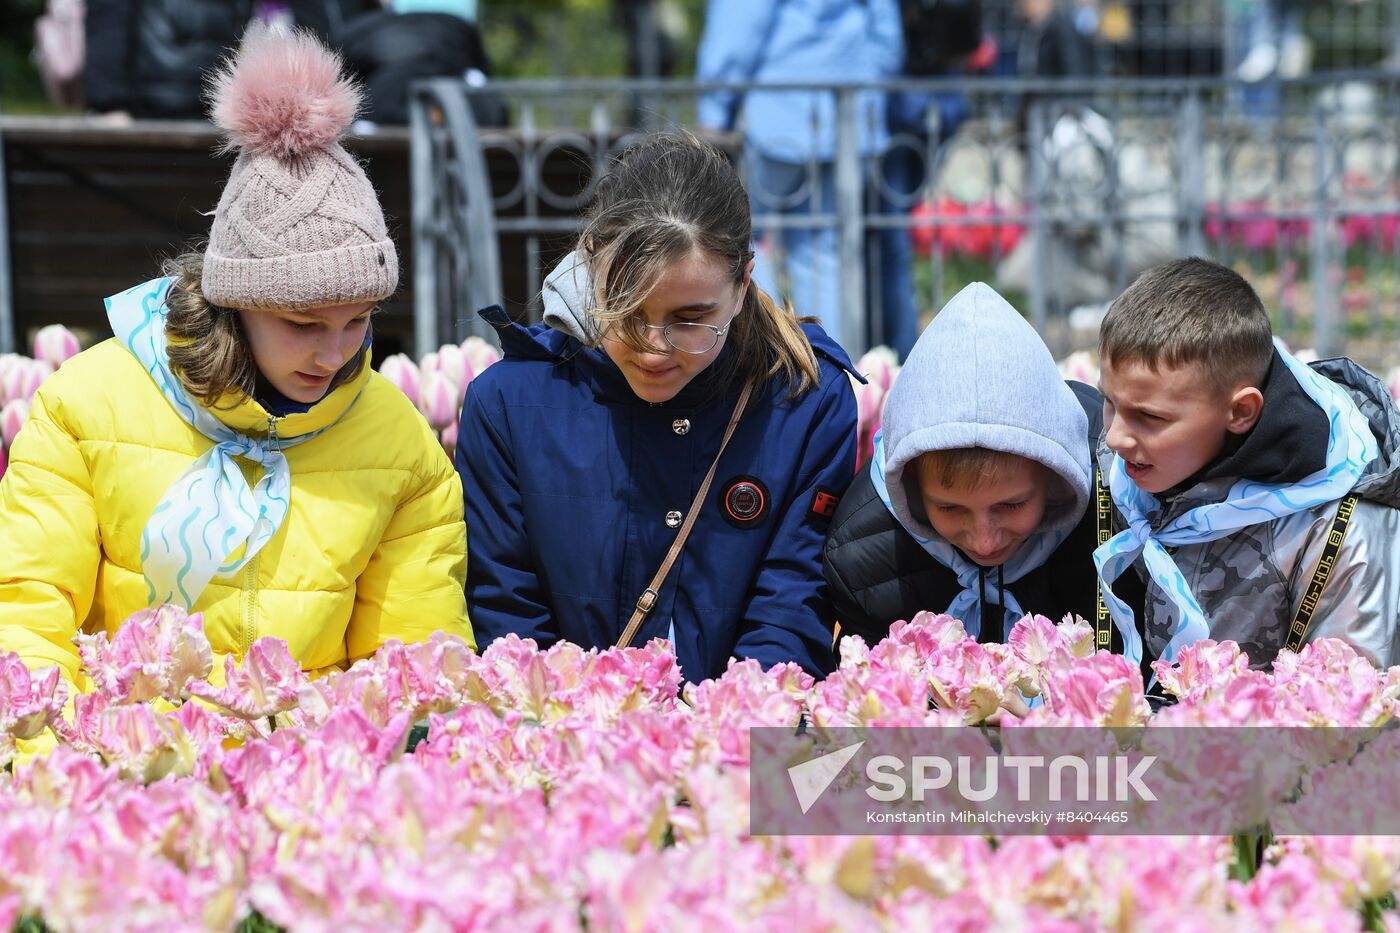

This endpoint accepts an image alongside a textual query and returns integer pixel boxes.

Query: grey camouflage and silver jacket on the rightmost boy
[1098,359,1400,667]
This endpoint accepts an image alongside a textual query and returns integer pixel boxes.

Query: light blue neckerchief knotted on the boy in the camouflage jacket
[1093,339,1379,664]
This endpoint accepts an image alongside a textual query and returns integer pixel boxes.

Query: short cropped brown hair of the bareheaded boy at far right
[1099,256,1274,392]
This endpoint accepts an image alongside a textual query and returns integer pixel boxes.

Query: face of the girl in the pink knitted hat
[238,303,374,403]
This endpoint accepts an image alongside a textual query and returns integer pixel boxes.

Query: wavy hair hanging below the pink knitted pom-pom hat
[161,252,365,408]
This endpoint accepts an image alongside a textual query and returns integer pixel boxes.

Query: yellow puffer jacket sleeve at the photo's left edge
[0,380,101,684]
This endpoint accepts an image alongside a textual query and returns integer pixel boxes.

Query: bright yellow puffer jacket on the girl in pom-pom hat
[0,332,472,689]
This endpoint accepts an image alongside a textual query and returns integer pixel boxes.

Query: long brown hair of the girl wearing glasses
[578,133,820,398]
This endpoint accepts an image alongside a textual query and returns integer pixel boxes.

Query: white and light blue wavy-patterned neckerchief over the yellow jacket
[106,279,354,611]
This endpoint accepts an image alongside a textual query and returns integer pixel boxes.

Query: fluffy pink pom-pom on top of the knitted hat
[210,24,360,160]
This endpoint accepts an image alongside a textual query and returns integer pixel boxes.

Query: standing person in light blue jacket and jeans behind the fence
[696,0,903,339]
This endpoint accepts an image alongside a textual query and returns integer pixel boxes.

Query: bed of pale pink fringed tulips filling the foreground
[0,608,1400,932]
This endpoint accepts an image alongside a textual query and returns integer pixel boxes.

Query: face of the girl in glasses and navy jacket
[603,249,753,403]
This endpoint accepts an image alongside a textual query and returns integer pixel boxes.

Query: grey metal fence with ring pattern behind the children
[413,71,1400,367]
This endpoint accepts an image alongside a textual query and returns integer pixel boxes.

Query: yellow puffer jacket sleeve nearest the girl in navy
[346,448,476,663]
